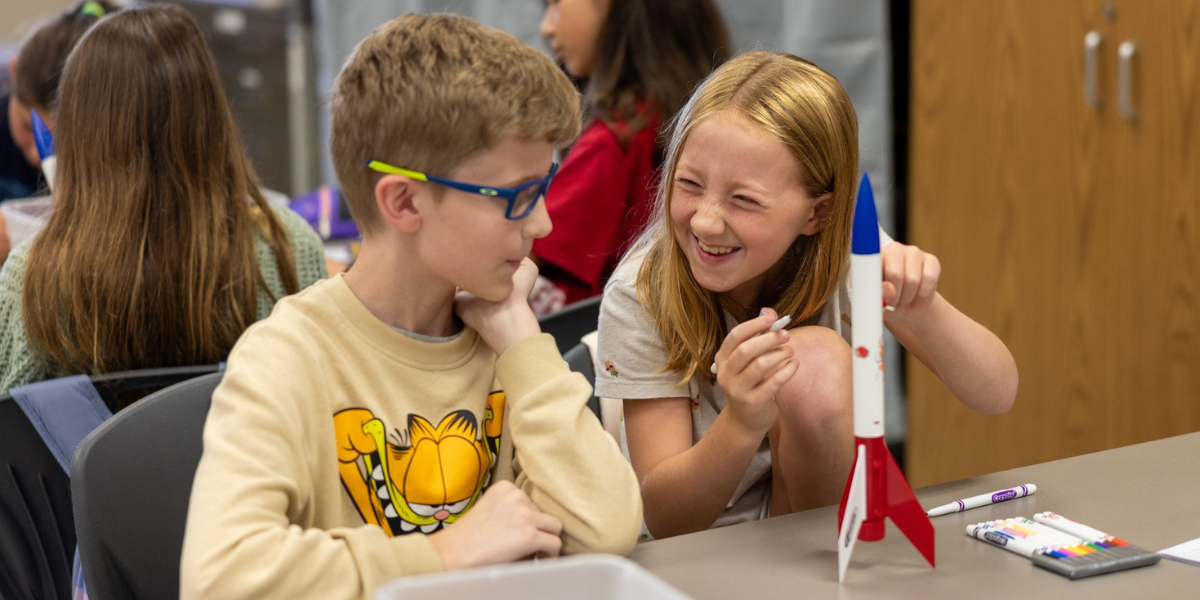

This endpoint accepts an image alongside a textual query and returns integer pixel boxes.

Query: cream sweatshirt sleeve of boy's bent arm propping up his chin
[497,334,642,554]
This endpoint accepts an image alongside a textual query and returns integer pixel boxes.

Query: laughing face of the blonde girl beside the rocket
[670,109,832,308]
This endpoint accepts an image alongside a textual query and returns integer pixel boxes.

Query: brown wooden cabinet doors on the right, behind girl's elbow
[906,0,1200,485]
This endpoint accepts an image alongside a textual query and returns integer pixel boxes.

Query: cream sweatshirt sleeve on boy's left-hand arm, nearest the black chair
[180,318,443,600]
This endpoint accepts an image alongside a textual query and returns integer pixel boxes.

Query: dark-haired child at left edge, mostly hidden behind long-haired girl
[0,0,116,263]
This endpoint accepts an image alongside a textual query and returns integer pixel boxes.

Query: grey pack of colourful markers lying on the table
[966,512,1160,580]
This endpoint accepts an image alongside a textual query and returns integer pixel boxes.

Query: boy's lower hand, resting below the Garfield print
[430,477,563,571]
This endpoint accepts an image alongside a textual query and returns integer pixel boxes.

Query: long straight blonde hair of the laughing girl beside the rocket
[630,52,858,380]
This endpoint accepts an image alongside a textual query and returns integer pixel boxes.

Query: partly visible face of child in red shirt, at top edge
[541,0,610,79]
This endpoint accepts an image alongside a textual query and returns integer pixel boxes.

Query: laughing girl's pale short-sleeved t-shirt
[595,229,892,527]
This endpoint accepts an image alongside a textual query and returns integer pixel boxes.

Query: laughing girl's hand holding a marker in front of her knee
[716,308,798,434]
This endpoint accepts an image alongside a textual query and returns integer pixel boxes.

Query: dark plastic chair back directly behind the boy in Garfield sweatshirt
[71,373,223,600]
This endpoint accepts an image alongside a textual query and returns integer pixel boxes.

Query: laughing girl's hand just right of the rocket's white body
[880,241,942,320]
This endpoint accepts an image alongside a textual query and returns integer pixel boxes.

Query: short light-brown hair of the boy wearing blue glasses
[330,14,581,233]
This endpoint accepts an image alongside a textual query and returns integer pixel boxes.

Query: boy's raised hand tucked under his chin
[454,258,541,356]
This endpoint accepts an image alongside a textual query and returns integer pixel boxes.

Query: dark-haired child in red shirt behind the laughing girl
[533,0,731,307]
